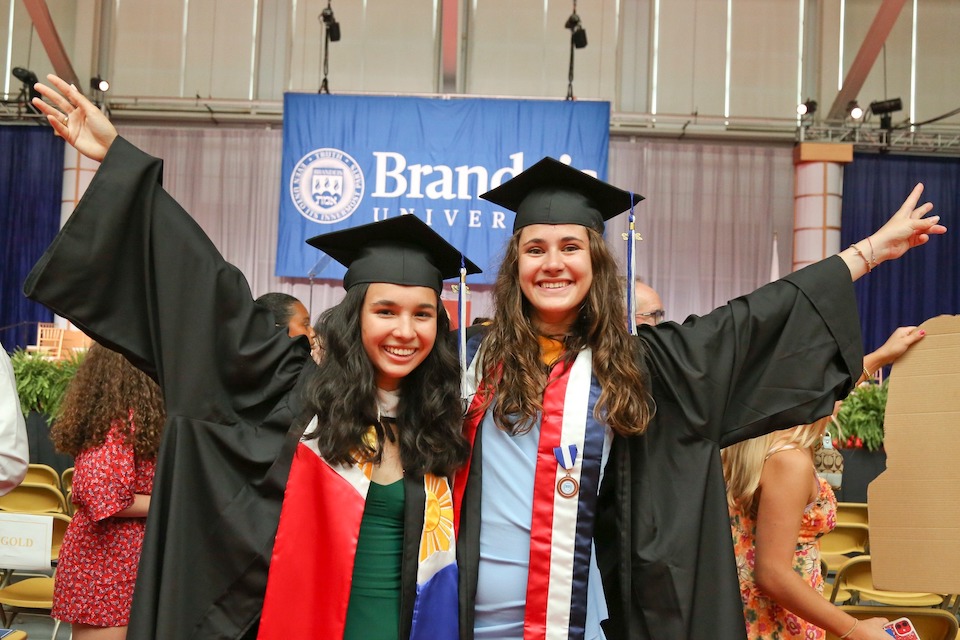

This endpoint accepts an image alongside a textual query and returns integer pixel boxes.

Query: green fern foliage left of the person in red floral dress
[10,349,83,421]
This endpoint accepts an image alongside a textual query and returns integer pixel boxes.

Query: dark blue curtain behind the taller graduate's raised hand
[840,153,960,353]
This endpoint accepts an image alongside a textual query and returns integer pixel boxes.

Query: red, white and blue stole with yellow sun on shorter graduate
[257,419,459,640]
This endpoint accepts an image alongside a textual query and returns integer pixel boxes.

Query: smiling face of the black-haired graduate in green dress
[360,282,438,391]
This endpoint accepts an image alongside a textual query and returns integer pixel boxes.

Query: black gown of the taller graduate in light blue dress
[458,257,863,640]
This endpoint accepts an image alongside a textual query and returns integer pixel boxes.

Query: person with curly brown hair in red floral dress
[50,345,165,640]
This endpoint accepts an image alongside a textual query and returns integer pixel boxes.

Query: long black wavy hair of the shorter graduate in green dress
[305,284,469,475]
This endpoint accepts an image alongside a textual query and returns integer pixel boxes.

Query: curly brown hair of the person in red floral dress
[50,344,166,458]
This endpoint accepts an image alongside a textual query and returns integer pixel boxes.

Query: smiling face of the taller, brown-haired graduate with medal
[518,224,593,335]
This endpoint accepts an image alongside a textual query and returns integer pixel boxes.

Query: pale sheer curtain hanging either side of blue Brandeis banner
[112,127,793,321]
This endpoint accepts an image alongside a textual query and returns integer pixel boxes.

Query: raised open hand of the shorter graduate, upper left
[32,74,117,162]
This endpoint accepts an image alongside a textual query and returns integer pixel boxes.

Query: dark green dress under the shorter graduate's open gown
[343,480,404,640]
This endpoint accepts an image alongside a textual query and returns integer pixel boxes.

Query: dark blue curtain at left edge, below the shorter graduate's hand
[0,125,63,351]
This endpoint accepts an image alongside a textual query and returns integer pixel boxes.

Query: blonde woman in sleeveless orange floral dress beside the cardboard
[721,327,924,640]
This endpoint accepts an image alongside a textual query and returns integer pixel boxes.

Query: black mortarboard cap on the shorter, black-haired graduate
[307,215,480,293]
